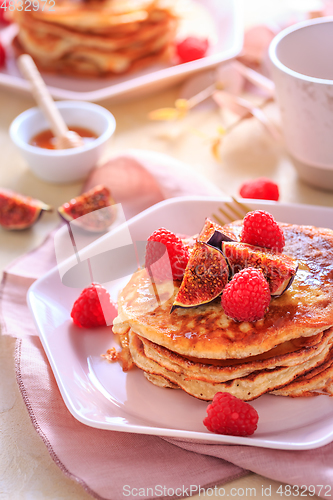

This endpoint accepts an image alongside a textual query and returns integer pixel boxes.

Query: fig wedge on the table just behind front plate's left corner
[58,184,116,232]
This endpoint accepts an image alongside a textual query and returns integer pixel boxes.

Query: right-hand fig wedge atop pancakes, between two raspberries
[222,241,298,297]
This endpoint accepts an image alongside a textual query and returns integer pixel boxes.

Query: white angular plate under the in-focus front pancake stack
[28,197,333,450]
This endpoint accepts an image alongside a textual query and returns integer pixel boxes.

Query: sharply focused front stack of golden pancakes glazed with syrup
[113,224,333,401]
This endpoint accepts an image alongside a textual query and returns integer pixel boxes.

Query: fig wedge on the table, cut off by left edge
[0,188,52,230]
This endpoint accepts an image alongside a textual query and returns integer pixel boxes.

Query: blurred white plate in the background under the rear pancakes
[0,0,243,102]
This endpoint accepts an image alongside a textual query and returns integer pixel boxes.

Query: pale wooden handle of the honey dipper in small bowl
[18,54,68,138]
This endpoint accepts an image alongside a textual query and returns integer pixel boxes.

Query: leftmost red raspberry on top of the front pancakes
[145,227,189,281]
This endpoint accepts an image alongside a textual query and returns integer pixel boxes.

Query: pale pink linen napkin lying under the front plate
[0,155,333,500]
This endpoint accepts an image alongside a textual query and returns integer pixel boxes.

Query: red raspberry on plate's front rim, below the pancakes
[203,392,259,436]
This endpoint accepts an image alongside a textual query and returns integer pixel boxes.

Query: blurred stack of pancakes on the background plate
[14,0,178,77]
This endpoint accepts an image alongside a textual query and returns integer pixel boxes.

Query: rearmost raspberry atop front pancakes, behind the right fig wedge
[241,210,285,252]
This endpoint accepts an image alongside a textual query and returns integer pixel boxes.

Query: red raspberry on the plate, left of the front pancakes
[71,283,117,328]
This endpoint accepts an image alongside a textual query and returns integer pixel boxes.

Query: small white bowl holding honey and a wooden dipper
[9,101,116,183]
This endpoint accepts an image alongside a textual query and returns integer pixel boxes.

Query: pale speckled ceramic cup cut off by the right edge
[269,17,333,190]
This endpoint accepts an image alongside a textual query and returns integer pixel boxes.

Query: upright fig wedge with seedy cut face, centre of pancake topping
[171,241,229,312]
